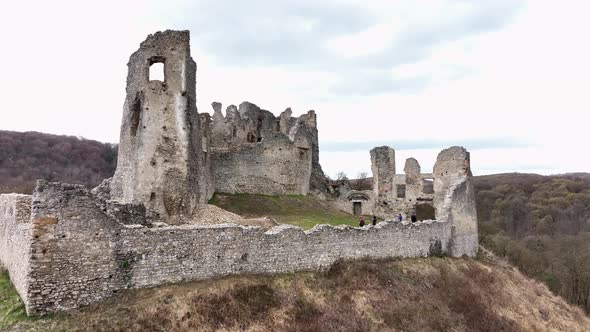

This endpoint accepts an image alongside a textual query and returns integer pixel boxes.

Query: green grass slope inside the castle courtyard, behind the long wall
[209,193,370,229]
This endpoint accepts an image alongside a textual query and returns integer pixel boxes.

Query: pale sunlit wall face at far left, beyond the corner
[0,194,31,299]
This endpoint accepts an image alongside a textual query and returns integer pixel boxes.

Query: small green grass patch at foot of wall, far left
[0,269,29,331]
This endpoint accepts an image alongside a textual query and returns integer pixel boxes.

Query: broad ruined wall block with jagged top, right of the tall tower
[211,102,325,195]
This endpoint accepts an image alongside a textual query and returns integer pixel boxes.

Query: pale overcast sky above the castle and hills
[0,0,590,177]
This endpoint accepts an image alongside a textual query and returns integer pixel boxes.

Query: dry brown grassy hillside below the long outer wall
[0,254,590,331]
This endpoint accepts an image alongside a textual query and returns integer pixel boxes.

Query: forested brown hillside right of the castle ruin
[475,173,590,312]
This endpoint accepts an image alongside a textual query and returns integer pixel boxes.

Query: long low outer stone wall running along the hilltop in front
[25,181,450,313]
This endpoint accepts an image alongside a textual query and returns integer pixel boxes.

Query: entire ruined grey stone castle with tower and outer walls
[0,31,478,314]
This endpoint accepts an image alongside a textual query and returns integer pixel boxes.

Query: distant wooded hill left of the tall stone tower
[0,131,117,194]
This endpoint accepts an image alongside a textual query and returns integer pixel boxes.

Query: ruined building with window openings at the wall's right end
[333,146,478,248]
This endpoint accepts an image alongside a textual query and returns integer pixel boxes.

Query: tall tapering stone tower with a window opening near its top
[111,30,209,223]
